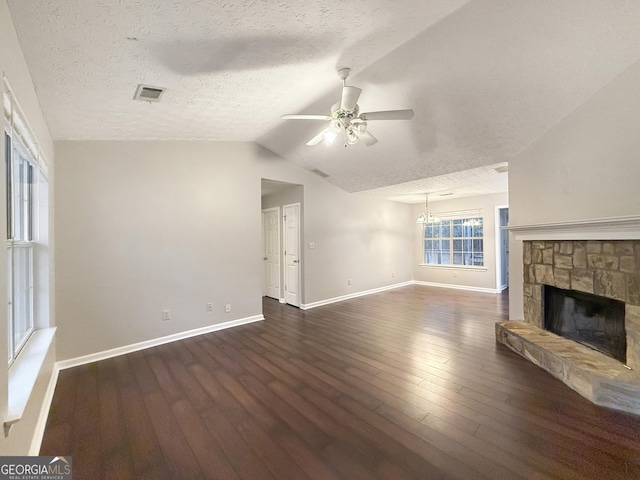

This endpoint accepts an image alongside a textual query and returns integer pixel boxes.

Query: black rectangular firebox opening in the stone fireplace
[543,285,627,363]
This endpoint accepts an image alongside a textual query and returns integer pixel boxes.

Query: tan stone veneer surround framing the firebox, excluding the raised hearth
[523,240,640,370]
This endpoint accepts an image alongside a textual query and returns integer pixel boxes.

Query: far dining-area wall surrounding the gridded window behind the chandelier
[413,193,508,290]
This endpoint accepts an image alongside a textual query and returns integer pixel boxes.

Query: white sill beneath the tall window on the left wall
[4,327,56,437]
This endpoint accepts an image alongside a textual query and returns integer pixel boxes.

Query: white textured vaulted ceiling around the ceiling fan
[8,0,640,199]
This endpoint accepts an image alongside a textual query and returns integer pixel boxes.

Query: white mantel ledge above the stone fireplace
[501,215,640,240]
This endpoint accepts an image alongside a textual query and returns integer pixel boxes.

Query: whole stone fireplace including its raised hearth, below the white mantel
[496,240,640,414]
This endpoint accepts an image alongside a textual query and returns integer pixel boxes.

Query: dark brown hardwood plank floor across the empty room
[41,286,640,480]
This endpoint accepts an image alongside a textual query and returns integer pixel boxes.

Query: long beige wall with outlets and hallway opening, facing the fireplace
[55,141,412,360]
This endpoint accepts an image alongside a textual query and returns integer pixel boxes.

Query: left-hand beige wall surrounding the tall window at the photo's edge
[0,0,55,455]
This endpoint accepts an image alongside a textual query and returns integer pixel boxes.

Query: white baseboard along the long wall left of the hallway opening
[56,314,264,370]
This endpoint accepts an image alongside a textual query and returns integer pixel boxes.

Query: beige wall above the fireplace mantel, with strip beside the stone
[509,62,640,319]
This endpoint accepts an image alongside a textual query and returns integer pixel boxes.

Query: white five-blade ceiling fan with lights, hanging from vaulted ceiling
[280,68,413,147]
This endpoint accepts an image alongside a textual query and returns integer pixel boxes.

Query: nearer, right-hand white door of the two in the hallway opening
[283,203,300,307]
